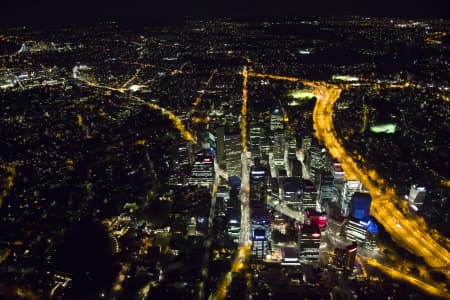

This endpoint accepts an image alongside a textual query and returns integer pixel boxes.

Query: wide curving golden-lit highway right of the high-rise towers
[313,85,450,269]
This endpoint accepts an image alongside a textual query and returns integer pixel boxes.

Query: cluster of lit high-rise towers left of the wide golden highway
[183,109,380,270]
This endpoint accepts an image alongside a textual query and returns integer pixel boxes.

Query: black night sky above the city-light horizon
[0,0,450,24]
